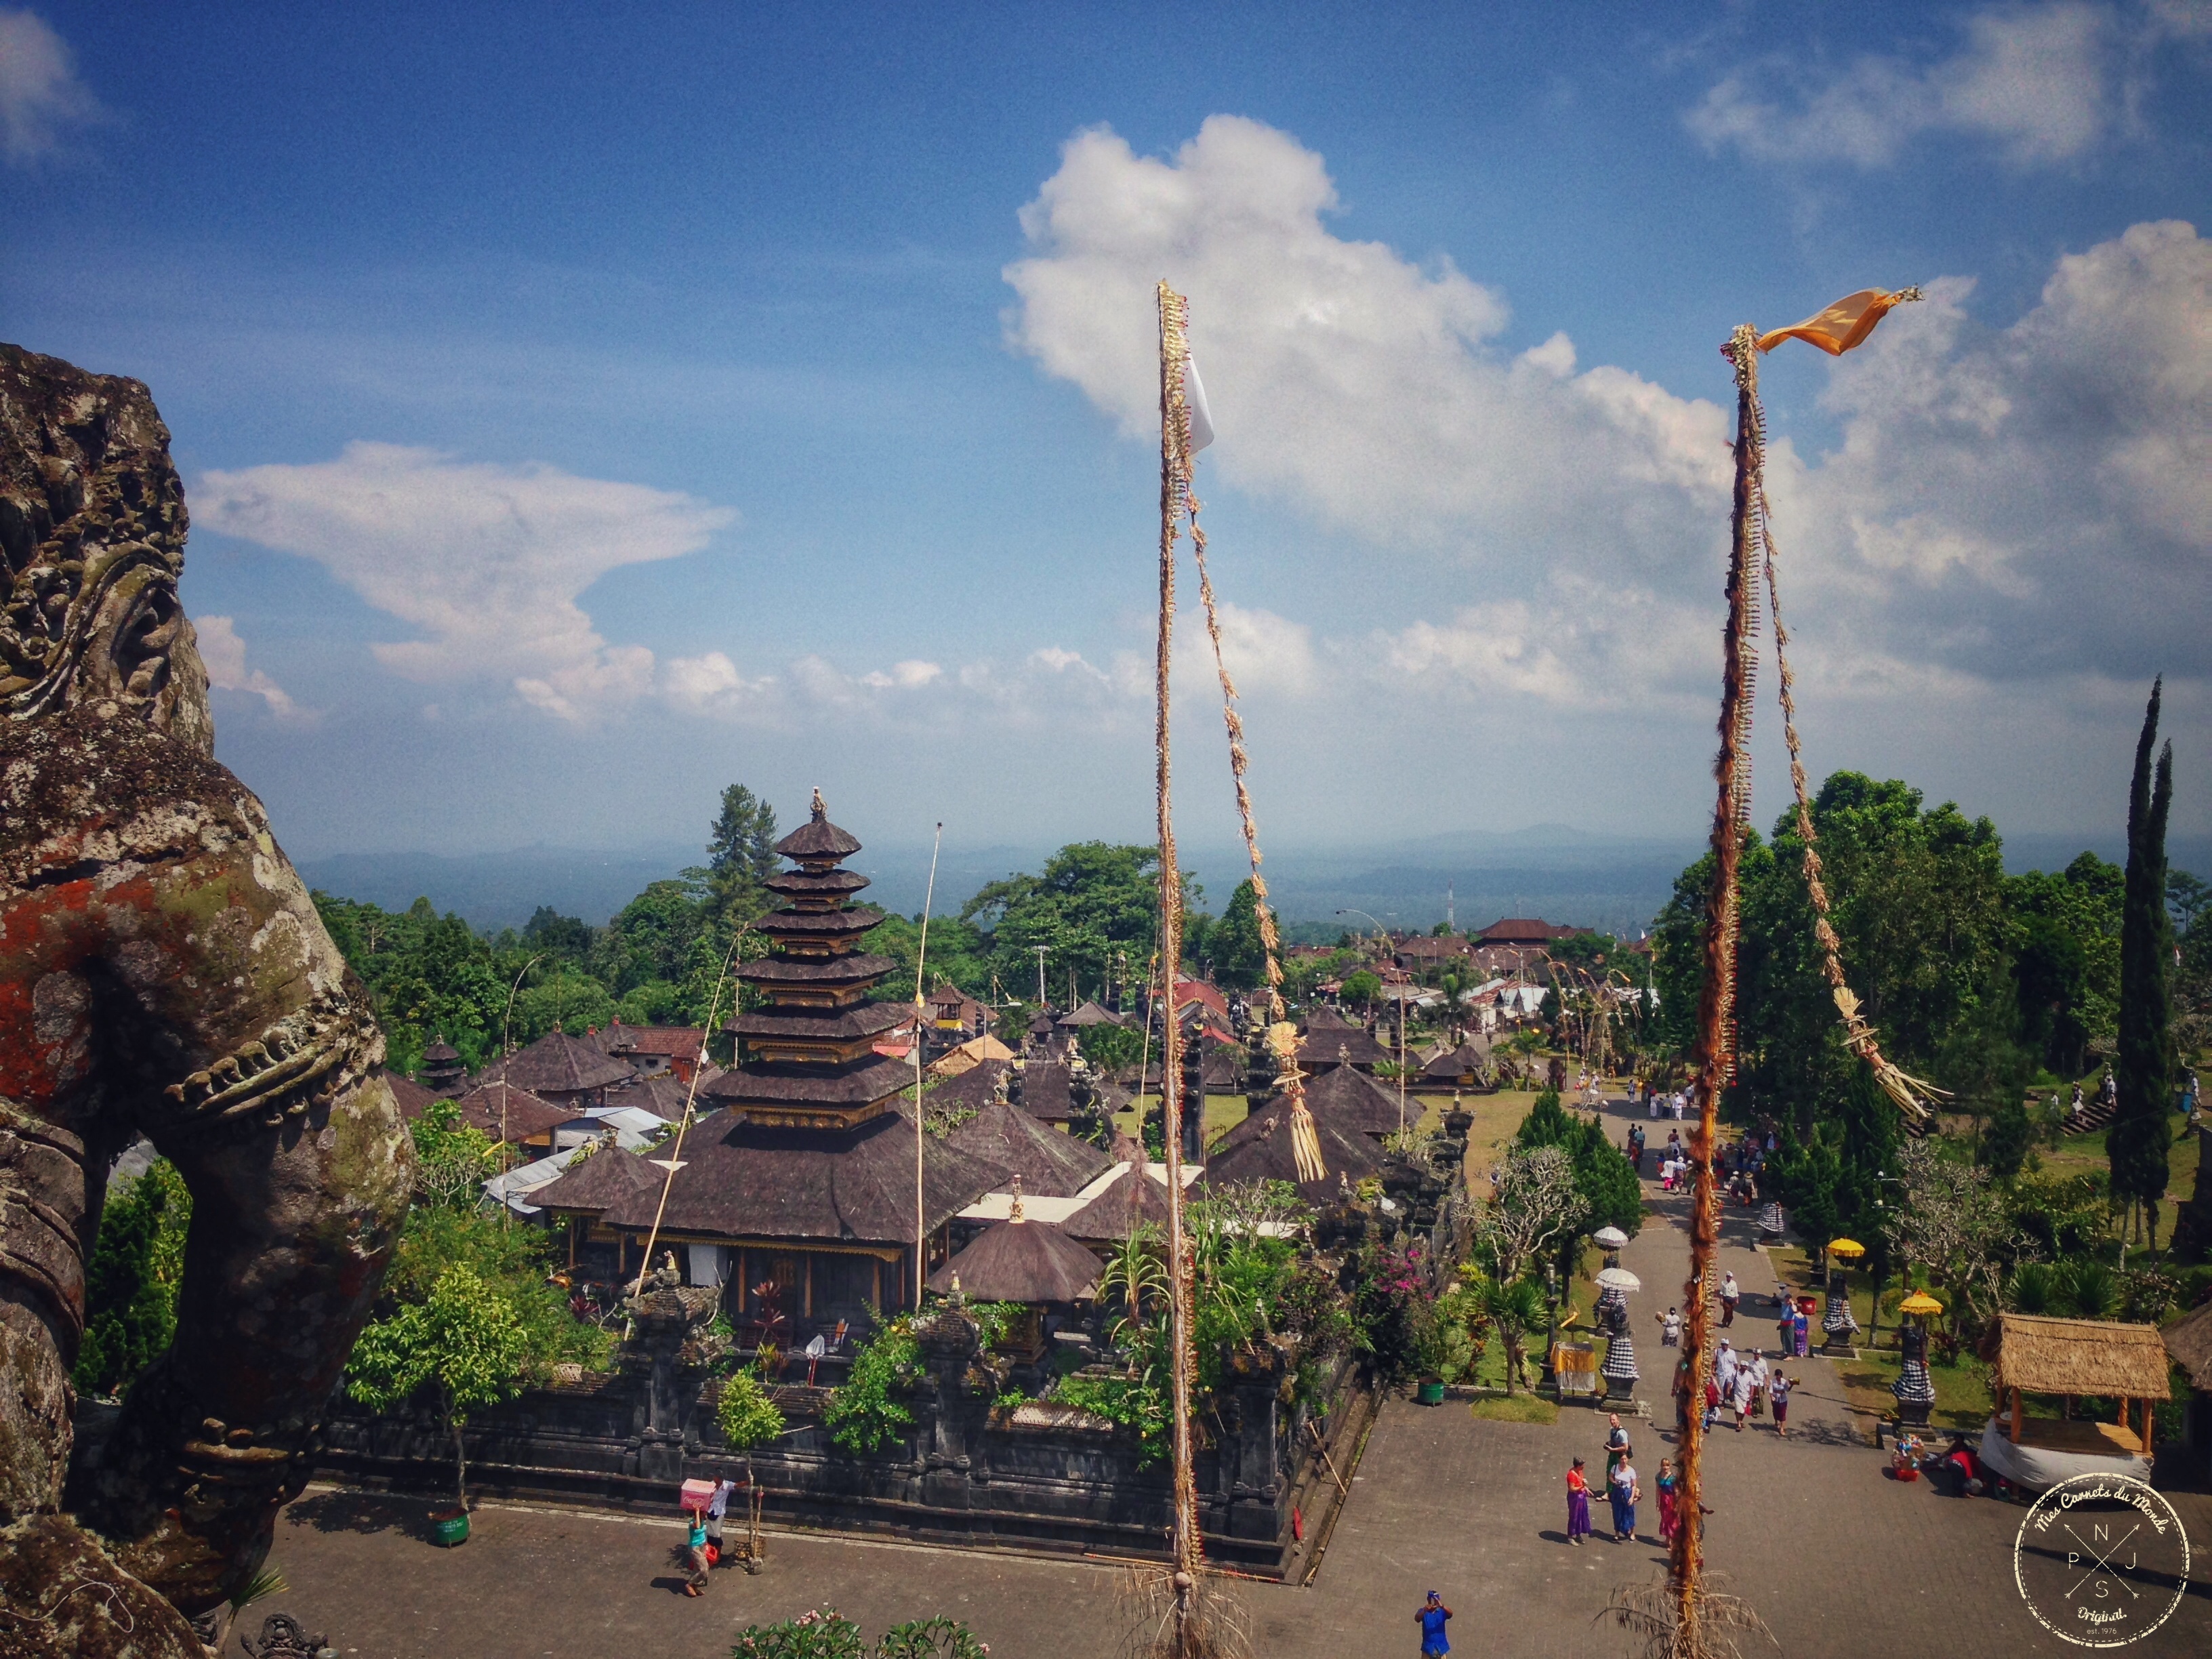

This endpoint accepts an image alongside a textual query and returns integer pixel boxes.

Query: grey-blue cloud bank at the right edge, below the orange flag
[1776,221,2212,681]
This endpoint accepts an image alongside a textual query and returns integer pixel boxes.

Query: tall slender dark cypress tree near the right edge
[2106,681,2175,1239]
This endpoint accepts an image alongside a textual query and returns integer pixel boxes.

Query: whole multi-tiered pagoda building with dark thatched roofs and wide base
[602,794,1006,1340]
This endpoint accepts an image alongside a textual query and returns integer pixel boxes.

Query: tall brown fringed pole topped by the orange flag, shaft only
[1670,325,1759,1652]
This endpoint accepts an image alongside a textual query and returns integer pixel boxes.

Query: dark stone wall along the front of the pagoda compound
[303,1363,1376,1577]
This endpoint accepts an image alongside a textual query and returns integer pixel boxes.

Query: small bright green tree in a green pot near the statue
[347,1263,529,1504]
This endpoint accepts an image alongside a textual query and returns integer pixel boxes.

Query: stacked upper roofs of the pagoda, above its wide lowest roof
[701,792,912,1128]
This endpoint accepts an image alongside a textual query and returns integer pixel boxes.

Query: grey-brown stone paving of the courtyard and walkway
[254,1111,2212,1659]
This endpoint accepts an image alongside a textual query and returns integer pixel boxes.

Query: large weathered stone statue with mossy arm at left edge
[0,345,411,1659]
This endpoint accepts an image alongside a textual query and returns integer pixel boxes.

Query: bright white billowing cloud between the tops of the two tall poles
[1006,115,1727,560]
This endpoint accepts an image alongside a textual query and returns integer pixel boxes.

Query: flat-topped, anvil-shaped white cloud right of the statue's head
[194,443,735,719]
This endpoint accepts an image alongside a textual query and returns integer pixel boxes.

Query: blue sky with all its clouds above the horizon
[0,0,2212,872]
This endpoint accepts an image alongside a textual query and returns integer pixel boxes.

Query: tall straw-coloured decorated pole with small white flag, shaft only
[1153,283,1199,1652]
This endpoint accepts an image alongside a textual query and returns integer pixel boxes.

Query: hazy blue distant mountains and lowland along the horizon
[301,825,2212,936]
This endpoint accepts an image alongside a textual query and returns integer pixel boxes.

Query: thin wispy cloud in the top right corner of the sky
[1685,0,2203,168]
